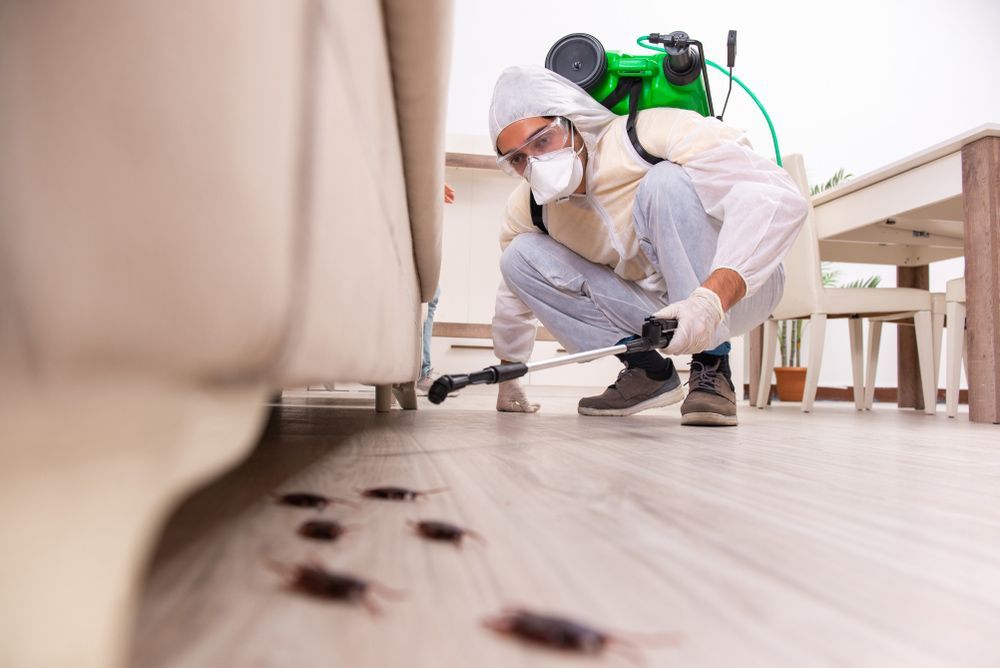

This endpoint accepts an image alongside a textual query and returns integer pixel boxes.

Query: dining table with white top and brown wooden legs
[751,123,1000,424]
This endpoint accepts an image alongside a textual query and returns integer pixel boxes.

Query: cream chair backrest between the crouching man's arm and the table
[772,154,823,320]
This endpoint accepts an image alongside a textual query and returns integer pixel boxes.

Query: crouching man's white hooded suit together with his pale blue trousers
[489,67,808,361]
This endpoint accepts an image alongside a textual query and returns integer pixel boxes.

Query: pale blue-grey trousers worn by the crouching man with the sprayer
[500,162,784,353]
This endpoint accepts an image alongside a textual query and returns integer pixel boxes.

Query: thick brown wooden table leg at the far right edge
[960,137,1000,424]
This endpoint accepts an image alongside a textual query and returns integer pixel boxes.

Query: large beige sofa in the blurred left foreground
[0,0,451,667]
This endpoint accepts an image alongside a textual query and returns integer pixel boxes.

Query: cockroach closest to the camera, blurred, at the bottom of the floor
[483,608,678,665]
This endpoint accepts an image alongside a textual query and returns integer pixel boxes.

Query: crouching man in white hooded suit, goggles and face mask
[489,67,808,425]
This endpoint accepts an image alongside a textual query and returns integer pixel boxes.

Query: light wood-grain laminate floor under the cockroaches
[132,388,1000,668]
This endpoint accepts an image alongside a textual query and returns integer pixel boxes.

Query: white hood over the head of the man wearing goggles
[490,65,617,155]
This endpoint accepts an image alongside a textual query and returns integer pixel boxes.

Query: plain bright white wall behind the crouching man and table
[441,0,1000,386]
